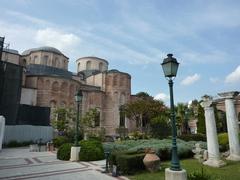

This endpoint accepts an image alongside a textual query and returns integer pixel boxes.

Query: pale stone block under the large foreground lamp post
[165,168,187,180]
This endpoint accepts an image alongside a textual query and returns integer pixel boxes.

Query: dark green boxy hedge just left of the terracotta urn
[109,151,145,174]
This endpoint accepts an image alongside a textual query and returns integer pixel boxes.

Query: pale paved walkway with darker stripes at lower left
[0,148,127,180]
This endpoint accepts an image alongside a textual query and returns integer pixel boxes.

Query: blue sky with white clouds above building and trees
[0,0,240,103]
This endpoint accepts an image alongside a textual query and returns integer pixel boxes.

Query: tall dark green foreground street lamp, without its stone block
[161,54,182,171]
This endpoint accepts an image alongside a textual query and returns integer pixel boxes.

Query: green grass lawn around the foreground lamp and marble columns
[129,159,240,180]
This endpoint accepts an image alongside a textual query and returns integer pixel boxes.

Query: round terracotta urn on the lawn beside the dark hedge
[143,151,160,172]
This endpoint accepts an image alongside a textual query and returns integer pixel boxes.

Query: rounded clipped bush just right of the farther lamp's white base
[79,140,104,161]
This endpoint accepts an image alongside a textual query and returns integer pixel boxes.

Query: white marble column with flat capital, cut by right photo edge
[218,91,240,161]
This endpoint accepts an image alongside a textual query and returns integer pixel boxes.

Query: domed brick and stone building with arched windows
[2,46,134,135]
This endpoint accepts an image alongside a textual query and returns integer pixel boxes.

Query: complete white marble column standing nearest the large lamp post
[201,95,225,167]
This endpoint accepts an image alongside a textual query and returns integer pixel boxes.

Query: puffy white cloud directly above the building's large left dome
[35,28,81,52]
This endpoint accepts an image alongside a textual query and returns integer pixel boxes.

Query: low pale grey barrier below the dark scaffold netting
[3,125,53,143]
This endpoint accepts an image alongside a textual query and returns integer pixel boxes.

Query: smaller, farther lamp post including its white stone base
[70,90,83,161]
